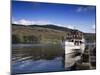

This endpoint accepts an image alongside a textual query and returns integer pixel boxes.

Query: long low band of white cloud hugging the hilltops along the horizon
[12,19,96,32]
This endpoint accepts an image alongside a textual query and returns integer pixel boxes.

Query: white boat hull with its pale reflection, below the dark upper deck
[65,41,85,69]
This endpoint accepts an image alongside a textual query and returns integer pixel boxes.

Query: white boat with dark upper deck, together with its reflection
[65,30,85,69]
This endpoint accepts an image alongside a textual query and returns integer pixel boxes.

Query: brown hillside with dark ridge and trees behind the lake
[12,24,95,44]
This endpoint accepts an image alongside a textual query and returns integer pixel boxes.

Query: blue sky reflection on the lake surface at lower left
[12,57,64,73]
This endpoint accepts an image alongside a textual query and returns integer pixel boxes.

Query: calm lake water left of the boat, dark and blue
[11,44,64,74]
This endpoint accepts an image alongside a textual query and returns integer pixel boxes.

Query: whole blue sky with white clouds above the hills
[11,1,96,33]
